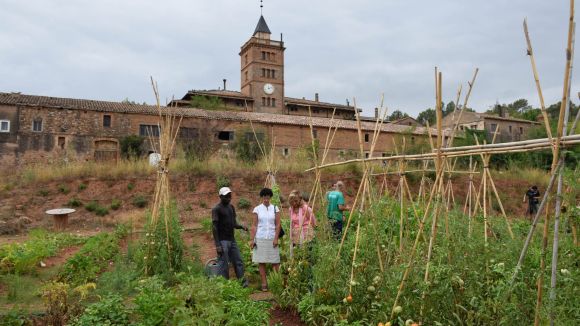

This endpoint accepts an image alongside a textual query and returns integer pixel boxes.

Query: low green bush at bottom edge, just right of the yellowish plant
[70,294,129,326]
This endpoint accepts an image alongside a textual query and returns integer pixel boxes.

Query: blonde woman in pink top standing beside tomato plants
[288,190,316,245]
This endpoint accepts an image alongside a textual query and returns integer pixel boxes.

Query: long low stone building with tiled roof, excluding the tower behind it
[0,93,435,166]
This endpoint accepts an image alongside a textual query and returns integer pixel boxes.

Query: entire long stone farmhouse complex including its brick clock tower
[0,16,436,167]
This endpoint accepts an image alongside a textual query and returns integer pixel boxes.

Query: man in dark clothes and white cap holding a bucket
[211,187,248,287]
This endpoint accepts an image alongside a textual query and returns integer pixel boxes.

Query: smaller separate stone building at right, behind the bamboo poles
[443,111,540,142]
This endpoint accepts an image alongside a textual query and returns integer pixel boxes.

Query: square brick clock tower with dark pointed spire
[240,16,285,114]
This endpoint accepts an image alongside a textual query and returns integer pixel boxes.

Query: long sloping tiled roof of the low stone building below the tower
[0,93,436,135]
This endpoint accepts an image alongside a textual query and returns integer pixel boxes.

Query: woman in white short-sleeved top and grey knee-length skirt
[250,188,280,291]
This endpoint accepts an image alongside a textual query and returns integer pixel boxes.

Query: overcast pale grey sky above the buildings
[0,0,580,117]
